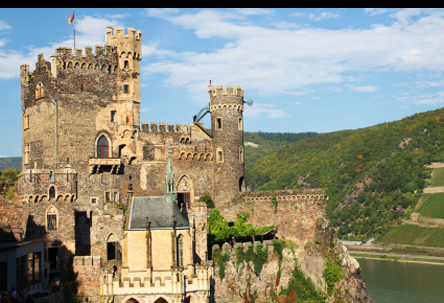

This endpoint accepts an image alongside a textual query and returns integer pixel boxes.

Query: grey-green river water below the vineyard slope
[356,258,444,303]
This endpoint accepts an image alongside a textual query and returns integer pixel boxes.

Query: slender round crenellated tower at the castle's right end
[209,84,245,205]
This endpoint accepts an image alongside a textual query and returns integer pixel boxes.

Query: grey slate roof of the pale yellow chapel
[129,196,190,230]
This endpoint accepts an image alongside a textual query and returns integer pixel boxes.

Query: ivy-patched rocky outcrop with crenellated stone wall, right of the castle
[213,191,372,303]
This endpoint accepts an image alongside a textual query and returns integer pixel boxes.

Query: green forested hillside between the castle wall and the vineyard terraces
[245,109,444,238]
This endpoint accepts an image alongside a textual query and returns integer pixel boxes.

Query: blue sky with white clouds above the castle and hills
[0,8,444,157]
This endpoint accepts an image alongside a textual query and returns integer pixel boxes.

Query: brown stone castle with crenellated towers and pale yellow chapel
[5,27,325,303]
